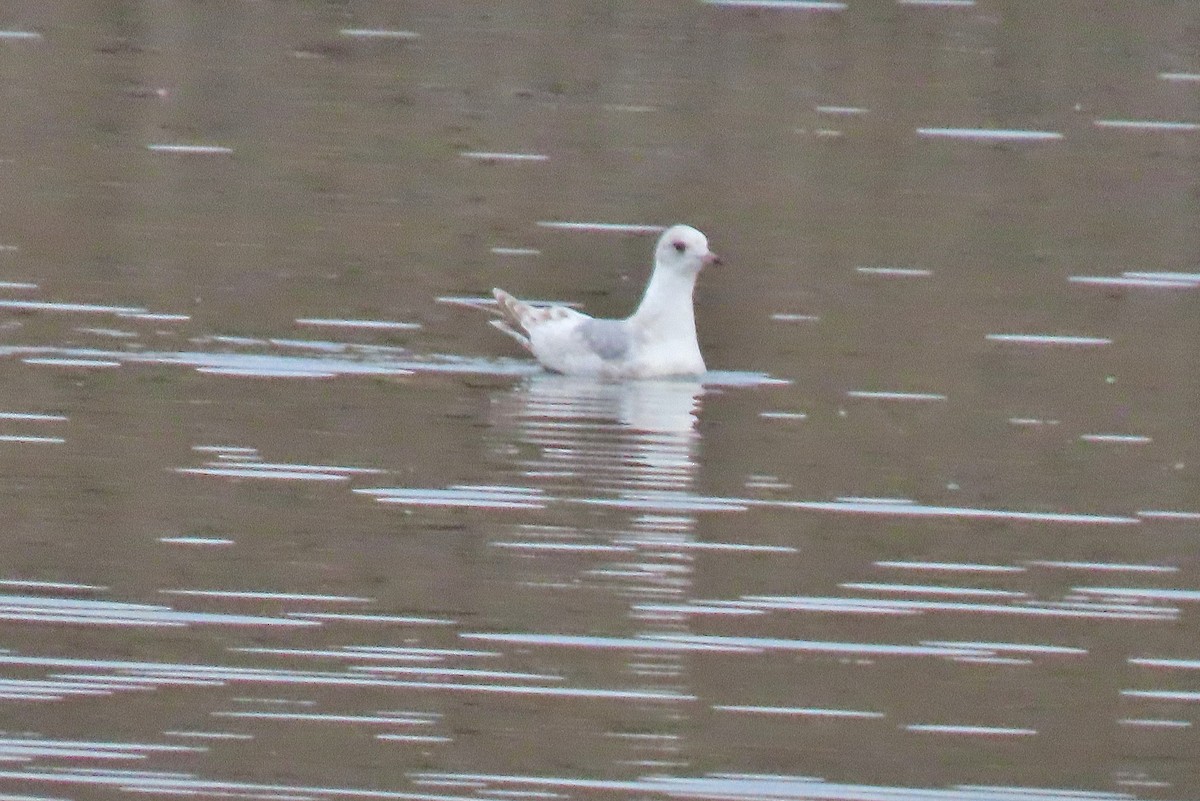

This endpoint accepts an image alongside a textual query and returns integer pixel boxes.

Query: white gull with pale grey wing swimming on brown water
[492,225,721,379]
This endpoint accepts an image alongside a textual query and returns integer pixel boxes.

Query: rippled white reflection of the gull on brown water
[491,374,704,766]
